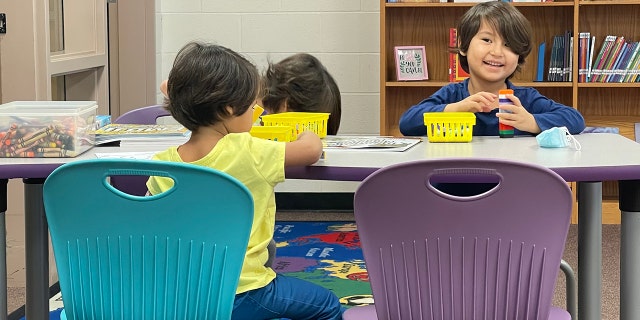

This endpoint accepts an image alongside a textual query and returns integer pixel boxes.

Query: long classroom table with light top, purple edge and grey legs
[0,133,640,320]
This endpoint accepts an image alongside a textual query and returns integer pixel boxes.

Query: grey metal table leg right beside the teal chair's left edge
[22,179,49,319]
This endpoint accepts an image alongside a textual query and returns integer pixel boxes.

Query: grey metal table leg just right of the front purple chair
[578,182,602,320]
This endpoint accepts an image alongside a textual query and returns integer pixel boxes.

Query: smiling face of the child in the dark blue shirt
[462,21,518,82]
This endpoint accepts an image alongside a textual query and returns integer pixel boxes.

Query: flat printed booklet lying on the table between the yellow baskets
[322,136,422,152]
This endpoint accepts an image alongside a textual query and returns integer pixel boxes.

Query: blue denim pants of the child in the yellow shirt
[231,274,344,320]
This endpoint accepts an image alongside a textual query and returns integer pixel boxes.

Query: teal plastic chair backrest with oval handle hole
[43,159,253,319]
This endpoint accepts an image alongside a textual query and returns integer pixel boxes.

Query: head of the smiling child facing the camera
[457,1,531,81]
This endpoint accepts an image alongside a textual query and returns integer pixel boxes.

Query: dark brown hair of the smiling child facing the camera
[457,1,532,78]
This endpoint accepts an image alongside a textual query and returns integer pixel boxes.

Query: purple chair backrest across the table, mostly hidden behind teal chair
[111,105,171,196]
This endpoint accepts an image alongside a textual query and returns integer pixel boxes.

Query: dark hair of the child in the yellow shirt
[165,42,260,132]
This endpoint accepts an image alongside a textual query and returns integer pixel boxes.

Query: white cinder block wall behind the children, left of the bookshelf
[156,0,380,192]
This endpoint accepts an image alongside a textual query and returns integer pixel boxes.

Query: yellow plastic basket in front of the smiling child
[424,112,476,142]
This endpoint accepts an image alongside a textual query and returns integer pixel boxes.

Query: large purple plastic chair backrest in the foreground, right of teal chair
[354,158,572,320]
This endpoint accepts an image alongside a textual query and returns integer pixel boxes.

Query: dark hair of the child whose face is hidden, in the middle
[262,53,342,135]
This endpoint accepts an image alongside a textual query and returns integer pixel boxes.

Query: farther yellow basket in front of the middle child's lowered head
[262,112,329,140]
